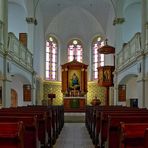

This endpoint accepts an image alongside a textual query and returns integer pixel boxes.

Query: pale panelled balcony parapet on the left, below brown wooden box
[8,32,33,69]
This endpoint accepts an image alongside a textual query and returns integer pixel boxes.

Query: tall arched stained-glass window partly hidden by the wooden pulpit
[92,36,104,79]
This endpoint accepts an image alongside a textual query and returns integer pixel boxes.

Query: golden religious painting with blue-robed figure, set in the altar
[68,70,81,90]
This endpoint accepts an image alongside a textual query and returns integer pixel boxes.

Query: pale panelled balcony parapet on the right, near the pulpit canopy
[117,32,143,69]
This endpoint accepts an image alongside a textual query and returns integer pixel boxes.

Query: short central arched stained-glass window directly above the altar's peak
[68,39,83,62]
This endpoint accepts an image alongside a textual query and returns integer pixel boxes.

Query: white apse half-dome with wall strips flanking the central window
[46,7,104,81]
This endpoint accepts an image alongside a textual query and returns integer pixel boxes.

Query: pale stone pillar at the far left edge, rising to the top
[0,0,11,107]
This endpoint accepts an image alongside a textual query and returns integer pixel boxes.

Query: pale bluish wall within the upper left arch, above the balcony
[8,2,28,37]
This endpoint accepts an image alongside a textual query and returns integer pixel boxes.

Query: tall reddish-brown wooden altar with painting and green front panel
[61,58,88,112]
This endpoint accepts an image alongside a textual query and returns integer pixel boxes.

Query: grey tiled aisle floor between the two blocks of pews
[53,123,94,148]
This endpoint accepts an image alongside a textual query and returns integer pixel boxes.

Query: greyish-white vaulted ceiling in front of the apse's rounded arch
[39,0,118,30]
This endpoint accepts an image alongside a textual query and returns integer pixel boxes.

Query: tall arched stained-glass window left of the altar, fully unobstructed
[46,36,58,80]
